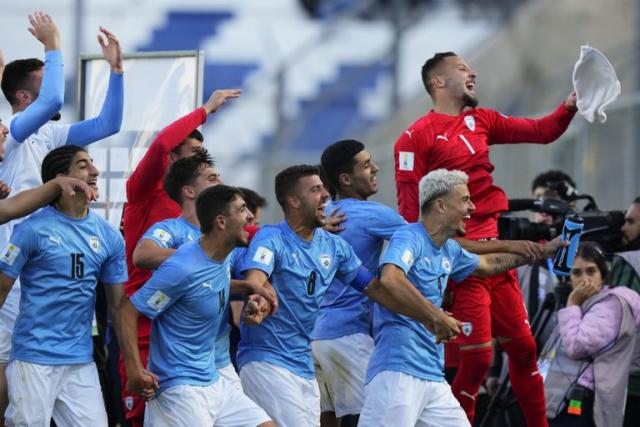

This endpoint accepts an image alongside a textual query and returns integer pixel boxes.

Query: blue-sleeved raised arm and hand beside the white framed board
[67,27,124,146]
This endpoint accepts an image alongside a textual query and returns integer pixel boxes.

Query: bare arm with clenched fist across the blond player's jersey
[364,264,461,342]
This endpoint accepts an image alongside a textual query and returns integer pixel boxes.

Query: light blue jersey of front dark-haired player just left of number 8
[131,240,237,393]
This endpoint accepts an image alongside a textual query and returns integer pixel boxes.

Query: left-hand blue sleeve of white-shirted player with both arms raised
[11,50,64,142]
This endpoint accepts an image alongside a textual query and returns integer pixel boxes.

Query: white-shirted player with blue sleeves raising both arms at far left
[0,12,124,421]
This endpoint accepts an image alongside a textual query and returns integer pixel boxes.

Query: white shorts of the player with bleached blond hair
[358,371,470,427]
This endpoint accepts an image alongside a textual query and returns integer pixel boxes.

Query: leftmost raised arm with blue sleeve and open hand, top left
[11,12,64,143]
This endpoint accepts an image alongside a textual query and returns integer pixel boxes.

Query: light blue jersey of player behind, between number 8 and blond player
[313,199,407,340]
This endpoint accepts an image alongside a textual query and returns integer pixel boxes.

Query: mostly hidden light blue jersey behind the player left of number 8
[140,217,234,369]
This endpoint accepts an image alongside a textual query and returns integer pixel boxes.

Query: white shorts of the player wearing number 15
[5,360,107,427]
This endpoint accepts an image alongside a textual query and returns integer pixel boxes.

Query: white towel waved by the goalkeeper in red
[573,46,620,123]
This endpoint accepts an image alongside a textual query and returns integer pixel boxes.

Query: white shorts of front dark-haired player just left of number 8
[144,377,270,427]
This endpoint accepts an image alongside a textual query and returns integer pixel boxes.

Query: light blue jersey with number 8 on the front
[238,221,360,379]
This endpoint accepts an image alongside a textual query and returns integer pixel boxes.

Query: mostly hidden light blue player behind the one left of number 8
[133,149,274,387]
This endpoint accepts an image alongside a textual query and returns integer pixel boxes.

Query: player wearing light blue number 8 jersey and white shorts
[238,165,464,426]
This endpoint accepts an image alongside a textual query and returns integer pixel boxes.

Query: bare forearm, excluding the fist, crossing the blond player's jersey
[365,264,440,330]
